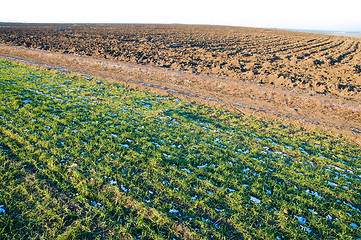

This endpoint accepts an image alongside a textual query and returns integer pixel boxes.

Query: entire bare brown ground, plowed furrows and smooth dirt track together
[0,25,361,142]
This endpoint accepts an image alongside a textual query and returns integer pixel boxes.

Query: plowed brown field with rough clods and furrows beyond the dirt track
[0,25,361,99]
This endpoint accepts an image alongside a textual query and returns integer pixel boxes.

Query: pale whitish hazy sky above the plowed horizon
[0,0,361,31]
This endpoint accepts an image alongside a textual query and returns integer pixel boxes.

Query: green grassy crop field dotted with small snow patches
[0,59,361,239]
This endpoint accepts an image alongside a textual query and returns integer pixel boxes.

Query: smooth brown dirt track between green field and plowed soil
[0,44,361,141]
